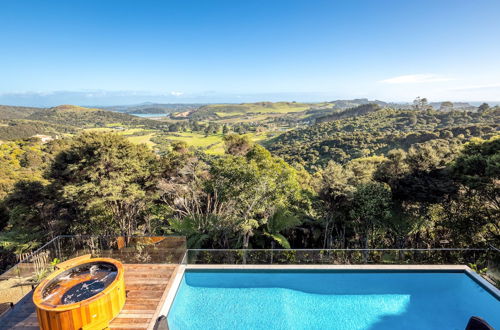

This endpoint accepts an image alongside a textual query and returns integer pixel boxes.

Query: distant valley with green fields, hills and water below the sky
[0,99,500,164]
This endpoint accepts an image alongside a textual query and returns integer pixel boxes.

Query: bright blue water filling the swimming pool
[168,270,500,330]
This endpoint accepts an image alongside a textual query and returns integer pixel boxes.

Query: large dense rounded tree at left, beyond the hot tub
[49,133,156,235]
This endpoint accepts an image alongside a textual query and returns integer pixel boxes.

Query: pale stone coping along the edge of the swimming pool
[159,264,500,316]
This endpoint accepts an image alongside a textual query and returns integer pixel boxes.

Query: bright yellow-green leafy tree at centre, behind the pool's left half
[207,145,301,248]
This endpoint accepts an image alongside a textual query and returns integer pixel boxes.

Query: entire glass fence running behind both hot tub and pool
[0,236,500,313]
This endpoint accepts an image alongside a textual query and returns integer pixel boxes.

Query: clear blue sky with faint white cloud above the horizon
[0,0,500,106]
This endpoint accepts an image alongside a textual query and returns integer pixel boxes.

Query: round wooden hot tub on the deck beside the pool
[33,255,125,330]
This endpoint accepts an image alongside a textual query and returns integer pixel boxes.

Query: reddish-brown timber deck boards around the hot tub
[0,264,177,330]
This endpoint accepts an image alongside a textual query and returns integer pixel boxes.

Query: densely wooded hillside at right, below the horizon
[265,107,500,169]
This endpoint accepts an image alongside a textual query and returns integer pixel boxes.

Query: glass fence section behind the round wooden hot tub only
[0,236,186,314]
